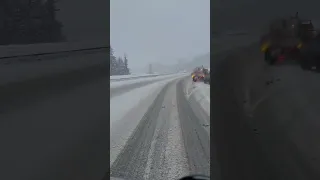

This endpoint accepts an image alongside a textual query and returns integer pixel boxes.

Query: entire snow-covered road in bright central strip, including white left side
[110,74,210,180]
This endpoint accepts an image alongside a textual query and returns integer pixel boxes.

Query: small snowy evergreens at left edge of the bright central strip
[110,48,130,75]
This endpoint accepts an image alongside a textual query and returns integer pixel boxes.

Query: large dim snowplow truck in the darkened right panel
[260,13,316,65]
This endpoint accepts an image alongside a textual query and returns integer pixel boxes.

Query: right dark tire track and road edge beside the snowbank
[177,79,210,175]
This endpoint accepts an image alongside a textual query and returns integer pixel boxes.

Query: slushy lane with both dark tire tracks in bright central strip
[110,78,210,180]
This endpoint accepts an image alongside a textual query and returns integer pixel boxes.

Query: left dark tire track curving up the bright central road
[110,81,174,179]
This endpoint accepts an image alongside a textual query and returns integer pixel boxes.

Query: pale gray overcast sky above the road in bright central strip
[110,0,210,68]
